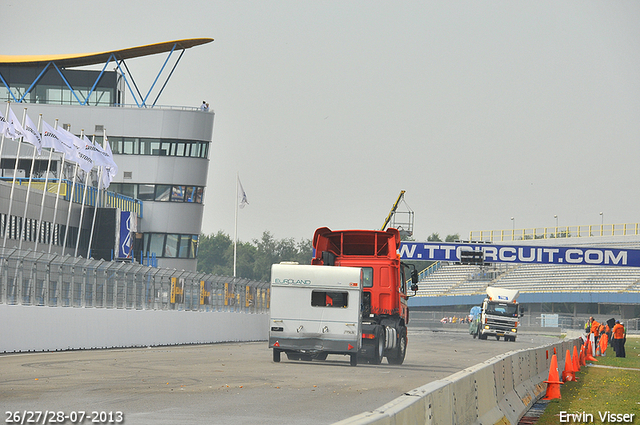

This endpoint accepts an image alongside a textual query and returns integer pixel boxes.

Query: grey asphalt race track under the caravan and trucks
[0,326,557,425]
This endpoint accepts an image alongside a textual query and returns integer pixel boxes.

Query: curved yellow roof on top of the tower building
[0,38,213,68]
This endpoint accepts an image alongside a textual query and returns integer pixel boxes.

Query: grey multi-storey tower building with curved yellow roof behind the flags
[0,38,214,271]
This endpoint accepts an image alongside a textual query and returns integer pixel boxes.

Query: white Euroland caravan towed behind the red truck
[269,263,363,366]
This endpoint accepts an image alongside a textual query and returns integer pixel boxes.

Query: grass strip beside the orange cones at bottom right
[538,338,640,425]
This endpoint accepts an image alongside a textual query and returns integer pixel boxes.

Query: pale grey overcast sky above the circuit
[5,0,640,242]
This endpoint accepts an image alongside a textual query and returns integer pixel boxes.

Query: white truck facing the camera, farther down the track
[469,286,523,341]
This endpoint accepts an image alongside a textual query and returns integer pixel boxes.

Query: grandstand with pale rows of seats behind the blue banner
[409,230,640,318]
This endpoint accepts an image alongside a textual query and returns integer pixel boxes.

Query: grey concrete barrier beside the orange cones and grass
[336,338,582,425]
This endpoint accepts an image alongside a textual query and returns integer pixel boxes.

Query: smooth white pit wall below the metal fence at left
[0,304,269,353]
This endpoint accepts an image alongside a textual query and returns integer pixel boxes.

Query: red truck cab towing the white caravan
[311,227,418,365]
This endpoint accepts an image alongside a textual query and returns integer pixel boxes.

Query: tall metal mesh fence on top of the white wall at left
[0,249,270,313]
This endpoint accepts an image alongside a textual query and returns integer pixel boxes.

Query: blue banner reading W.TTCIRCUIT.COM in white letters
[400,242,640,267]
